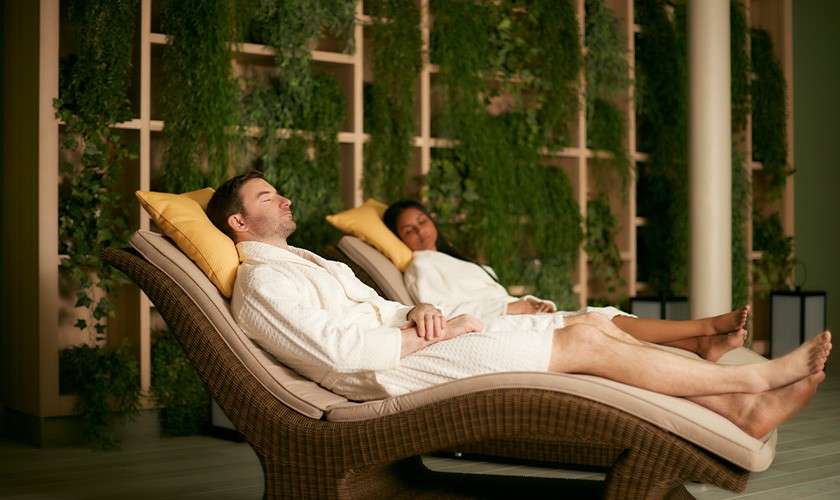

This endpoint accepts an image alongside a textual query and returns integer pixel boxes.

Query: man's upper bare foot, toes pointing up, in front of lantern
[755,330,831,389]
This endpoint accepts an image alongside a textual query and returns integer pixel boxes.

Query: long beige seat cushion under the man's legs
[327,348,776,472]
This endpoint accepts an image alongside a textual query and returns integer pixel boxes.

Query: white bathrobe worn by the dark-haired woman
[403,250,631,321]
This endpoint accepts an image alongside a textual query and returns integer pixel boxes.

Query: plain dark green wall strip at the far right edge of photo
[793,0,840,332]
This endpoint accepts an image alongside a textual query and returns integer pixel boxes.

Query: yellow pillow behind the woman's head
[327,198,411,271]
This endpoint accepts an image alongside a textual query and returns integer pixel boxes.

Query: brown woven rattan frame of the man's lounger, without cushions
[104,249,749,499]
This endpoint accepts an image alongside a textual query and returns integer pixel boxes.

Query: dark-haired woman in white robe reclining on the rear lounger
[384,200,750,361]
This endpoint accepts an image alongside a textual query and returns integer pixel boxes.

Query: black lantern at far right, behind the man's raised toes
[770,288,827,358]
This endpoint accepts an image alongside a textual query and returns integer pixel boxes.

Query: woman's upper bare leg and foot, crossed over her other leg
[612,305,750,344]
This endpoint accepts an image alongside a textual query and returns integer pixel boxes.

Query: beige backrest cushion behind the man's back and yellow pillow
[131,230,347,418]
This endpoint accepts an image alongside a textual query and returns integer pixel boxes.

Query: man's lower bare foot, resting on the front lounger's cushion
[732,371,825,438]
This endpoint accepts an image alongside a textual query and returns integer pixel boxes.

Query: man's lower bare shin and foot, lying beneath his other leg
[688,372,825,438]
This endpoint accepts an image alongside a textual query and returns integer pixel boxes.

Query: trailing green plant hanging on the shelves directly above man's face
[242,0,355,251]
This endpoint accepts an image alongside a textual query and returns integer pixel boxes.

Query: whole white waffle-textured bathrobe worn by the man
[231,242,563,401]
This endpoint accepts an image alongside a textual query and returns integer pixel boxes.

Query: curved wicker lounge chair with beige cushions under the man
[104,231,775,499]
